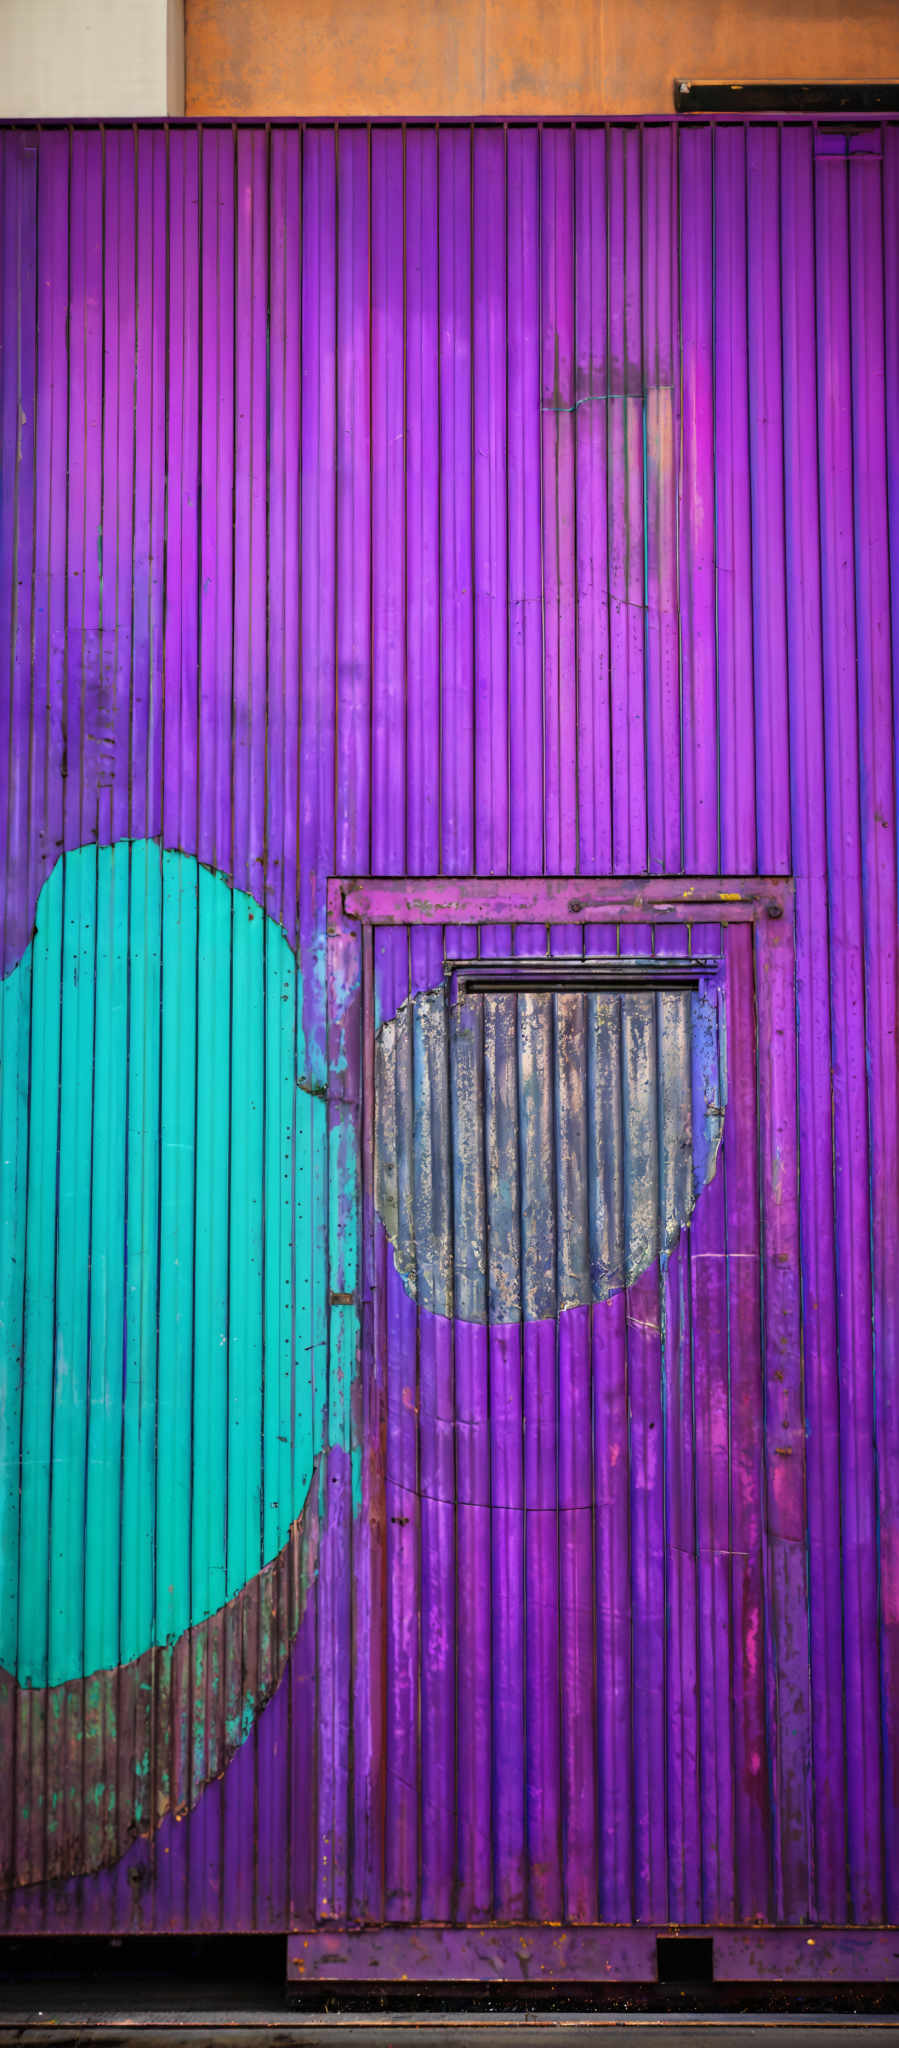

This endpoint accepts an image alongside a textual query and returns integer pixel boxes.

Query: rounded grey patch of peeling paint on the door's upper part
[375,985,725,1325]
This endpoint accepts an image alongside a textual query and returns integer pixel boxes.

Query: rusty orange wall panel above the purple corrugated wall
[184,0,899,117]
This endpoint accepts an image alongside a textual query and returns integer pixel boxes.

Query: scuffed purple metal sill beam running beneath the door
[287,1925,899,1985]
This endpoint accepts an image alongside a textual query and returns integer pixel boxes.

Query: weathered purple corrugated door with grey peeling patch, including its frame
[305,881,803,1974]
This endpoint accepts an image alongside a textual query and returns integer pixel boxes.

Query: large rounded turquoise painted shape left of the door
[0,840,319,1686]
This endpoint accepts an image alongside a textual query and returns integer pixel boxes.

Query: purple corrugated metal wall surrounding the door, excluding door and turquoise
[0,121,899,1931]
